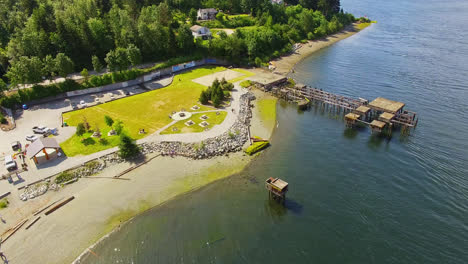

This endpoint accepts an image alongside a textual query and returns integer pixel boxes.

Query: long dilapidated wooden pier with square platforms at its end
[271,84,418,135]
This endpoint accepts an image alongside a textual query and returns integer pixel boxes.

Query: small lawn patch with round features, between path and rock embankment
[160,111,227,135]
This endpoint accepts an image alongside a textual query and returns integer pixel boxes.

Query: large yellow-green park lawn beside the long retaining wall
[61,67,226,157]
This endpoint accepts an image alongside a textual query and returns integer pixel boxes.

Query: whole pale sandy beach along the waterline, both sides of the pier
[0,22,372,263]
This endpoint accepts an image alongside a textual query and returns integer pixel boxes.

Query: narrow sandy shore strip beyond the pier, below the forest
[271,22,372,76]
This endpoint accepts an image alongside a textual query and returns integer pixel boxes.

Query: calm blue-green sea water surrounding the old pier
[85,0,468,263]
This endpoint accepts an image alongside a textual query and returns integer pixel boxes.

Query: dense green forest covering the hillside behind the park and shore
[0,0,355,89]
